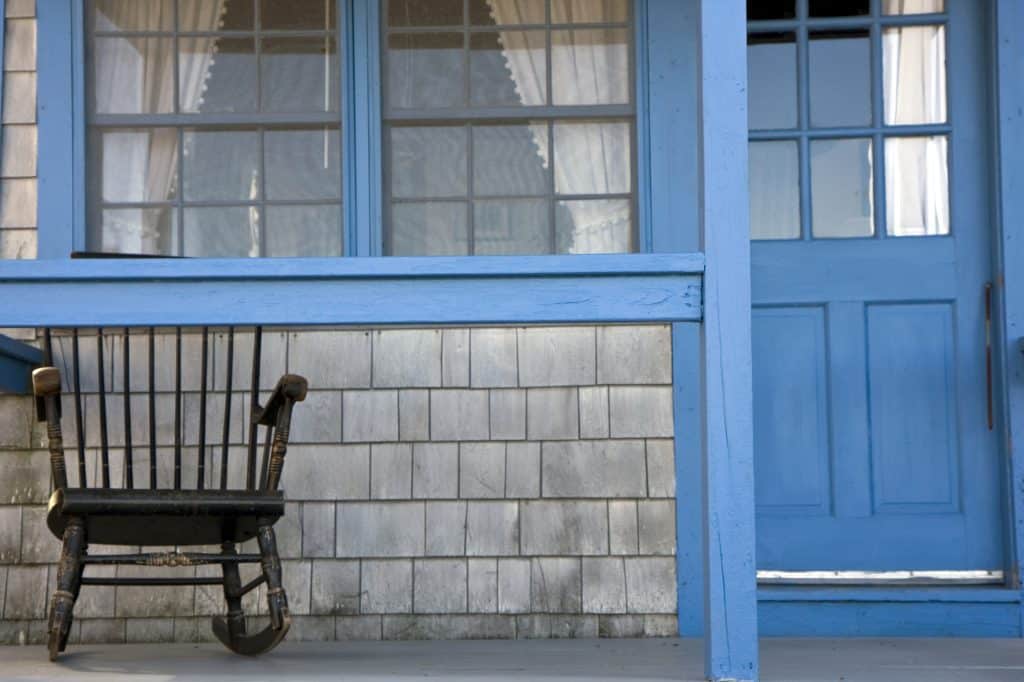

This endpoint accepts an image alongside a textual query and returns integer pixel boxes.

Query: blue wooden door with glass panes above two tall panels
[750,0,1002,571]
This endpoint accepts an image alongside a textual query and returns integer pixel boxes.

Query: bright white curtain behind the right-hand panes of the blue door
[883,23,949,236]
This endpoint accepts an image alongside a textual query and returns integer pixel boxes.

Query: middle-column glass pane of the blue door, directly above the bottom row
[809,30,871,127]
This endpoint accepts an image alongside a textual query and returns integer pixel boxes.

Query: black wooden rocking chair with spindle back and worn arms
[32,328,306,660]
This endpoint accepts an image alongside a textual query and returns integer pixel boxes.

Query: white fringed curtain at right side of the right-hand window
[487,0,632,253]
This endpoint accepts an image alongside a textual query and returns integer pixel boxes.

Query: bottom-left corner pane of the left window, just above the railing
[96,207,178,256]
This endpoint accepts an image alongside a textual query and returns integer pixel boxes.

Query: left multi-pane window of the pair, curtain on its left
[86,0,342,257]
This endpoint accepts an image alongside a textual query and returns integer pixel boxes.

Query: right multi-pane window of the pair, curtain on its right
[382,0,636,255]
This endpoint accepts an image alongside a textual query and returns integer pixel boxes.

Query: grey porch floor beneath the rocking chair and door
[0,639,1024,682]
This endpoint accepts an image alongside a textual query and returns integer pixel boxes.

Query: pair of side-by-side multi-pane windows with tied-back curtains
[85,0,638,257]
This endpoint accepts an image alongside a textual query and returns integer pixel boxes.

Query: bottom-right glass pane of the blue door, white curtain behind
[886,136,949,237]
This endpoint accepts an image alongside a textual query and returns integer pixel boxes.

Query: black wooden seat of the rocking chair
[46,487,285,545]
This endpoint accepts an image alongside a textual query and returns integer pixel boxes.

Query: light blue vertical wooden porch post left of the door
[699,0,758,680]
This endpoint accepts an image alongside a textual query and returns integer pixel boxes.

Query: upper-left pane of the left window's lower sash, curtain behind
[93,128,178,203]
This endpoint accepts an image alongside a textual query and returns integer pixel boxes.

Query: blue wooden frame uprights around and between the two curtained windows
[38,0,698,262]
